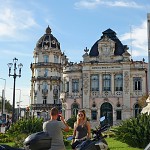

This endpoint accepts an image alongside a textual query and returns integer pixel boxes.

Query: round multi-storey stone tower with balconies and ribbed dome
[30,26,67,116]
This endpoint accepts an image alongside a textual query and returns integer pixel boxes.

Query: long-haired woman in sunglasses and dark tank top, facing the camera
[72,110,91,149]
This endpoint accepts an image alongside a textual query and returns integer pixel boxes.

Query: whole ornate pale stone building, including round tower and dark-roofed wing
[31,27,148,125]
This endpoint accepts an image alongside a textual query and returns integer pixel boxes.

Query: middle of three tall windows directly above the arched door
[103,74,111,91]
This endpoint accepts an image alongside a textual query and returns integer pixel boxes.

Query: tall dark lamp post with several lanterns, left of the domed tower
[7,58,23,123]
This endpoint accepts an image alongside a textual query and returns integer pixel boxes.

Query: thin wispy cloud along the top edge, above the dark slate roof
[75,0,143,9]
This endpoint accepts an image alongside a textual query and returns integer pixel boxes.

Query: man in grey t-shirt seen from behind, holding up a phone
[43,107,69,150]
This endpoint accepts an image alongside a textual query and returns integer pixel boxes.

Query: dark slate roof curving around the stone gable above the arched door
[89,29,125,56]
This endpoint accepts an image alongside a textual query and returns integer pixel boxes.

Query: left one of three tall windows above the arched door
[91,75,99,91]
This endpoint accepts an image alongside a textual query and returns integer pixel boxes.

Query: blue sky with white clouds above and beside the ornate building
[0,0,150,106]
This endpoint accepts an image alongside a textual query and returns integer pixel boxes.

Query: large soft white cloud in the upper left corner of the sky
[0,3,36,39]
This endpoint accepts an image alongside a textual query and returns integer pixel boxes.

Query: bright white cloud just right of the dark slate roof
[120,20,148,56]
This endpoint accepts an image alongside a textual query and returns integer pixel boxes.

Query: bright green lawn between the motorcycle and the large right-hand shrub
[66,138,143,150]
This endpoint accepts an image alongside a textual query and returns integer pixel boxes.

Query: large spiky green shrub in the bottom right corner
[114,114,150,148]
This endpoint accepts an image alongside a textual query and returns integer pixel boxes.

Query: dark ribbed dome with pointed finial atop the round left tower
[36,26,60,49]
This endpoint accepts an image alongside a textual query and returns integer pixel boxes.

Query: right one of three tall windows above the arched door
[115,74,123,91]
